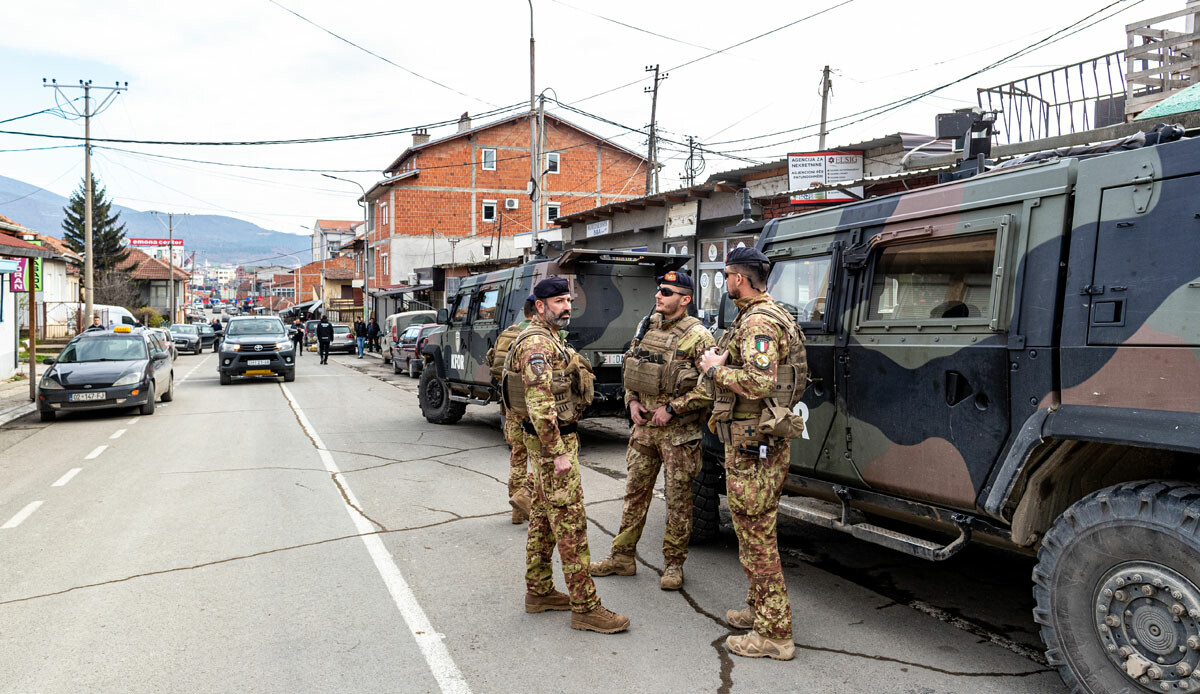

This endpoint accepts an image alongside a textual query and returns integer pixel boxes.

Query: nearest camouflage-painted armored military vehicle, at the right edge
[696,127,1200,693]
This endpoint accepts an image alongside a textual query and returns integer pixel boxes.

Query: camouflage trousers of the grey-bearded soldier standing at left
[526,433,600,612]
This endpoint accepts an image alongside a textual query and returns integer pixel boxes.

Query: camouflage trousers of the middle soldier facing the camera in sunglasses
[612,421,700,564]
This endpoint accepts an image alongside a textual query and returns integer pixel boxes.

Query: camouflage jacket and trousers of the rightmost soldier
[712,293,792,640]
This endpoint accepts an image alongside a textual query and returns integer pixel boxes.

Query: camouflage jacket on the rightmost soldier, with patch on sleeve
[713,292,791,400]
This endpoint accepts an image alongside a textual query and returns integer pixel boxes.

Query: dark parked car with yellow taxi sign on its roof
[37,325,175,421]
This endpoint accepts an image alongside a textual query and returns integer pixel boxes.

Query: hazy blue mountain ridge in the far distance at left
[0,171,312,265]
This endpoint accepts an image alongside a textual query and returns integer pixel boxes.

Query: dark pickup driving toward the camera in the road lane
[217,316,296,385]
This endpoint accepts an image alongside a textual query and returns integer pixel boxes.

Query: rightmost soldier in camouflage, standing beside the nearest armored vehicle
[701,247,800,660]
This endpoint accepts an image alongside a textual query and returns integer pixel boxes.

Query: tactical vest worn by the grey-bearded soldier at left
[500,324,595,424]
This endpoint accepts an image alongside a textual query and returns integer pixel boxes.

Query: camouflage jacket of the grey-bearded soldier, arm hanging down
[510,318,570,457]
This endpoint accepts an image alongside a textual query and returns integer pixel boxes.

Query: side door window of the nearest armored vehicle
[868,233,996,321]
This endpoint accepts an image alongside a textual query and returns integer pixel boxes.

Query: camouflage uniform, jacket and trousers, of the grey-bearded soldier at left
[510,318,600,612]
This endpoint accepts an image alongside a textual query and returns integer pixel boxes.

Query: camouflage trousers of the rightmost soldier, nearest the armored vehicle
[725,423,792,640]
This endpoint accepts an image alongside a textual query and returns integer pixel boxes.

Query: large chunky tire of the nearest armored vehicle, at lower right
[1033,480,1200,694]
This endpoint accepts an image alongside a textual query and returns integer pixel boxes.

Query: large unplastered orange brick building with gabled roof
[359,113,647,289]
